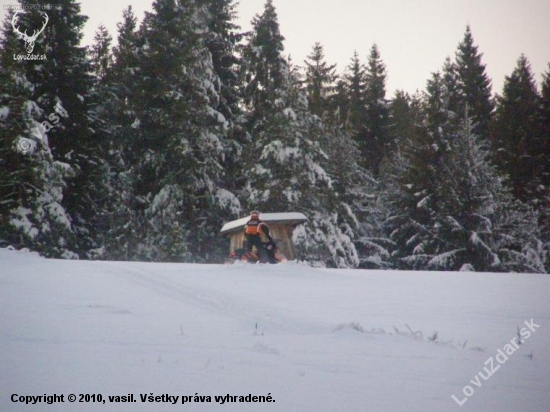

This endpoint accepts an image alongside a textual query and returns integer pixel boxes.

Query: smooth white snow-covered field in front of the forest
[0,249,550,412]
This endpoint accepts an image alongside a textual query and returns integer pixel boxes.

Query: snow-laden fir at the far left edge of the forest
[0,6,77,258]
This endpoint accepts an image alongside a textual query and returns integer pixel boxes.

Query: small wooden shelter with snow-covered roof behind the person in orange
[220,212,308,260]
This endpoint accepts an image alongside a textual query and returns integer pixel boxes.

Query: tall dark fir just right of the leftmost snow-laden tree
[12,0,111,257]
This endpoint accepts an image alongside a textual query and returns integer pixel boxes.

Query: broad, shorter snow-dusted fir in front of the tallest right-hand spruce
[385,89,545,272]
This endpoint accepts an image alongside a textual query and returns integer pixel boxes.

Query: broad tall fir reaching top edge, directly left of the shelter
[125,0,242,261]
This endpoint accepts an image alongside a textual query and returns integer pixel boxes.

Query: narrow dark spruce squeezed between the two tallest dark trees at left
[88,6,147,260]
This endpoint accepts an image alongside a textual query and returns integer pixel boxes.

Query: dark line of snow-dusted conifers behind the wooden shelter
[0,0,550,272]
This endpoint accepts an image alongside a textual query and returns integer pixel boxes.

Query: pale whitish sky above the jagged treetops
[0,0,550,97]
